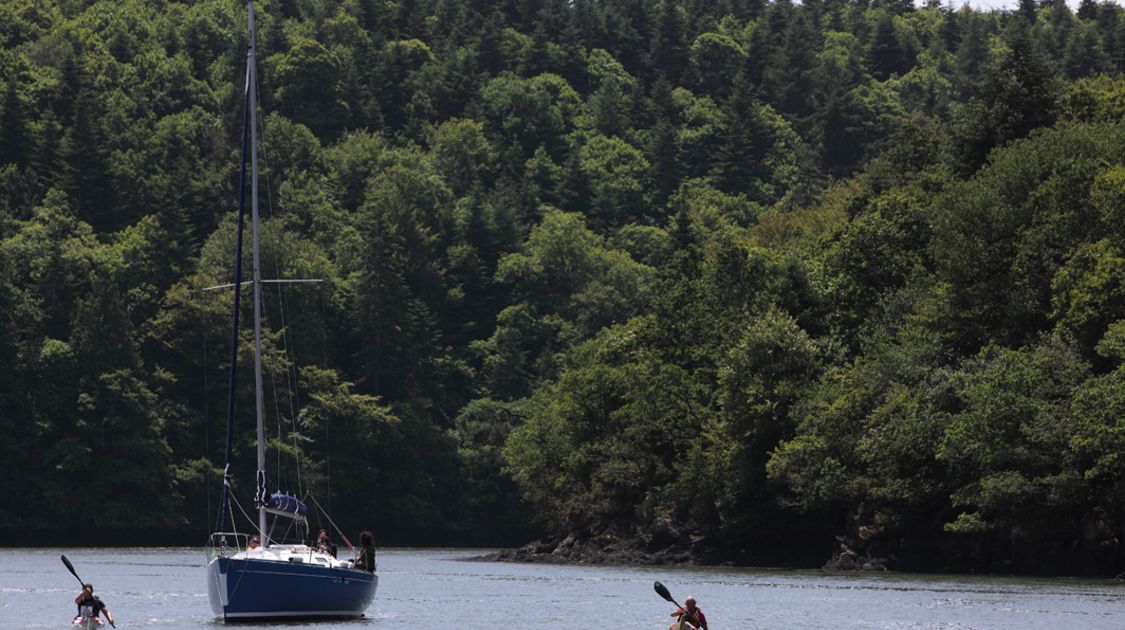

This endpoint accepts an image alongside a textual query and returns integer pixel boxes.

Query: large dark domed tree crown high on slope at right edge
[934,126,1121,352]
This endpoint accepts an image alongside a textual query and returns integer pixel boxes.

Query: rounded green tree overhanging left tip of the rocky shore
[504,323,698,531]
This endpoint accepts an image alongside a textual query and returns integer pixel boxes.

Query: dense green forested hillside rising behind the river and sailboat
[0,0,1125,575]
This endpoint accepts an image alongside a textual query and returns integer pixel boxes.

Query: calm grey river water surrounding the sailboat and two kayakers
[0,548,1125,630]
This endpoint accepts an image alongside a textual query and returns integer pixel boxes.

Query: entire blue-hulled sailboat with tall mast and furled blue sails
[207,0,379,621]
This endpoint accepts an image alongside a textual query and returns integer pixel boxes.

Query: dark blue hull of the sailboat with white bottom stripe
[207,557,379,620]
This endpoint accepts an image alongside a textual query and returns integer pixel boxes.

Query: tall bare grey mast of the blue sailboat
[246,0,270,547]
